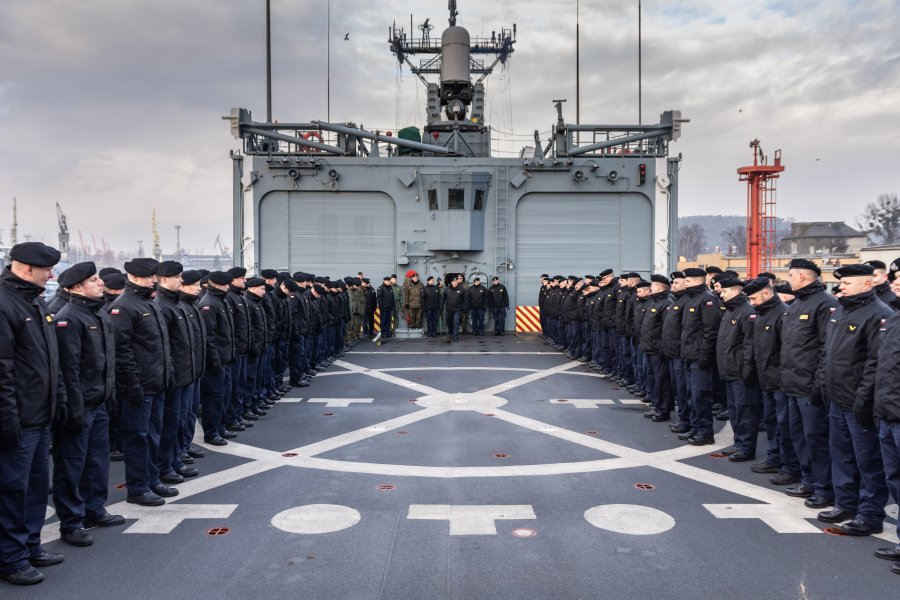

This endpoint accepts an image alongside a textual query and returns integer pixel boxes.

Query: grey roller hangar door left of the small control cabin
[259,192,397,283]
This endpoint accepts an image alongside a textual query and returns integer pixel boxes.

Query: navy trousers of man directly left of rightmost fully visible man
[788,396,834,500]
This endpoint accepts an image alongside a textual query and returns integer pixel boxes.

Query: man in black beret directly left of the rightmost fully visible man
[781,258,839,508]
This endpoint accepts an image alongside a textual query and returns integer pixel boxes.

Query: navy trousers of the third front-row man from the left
[119,394,165,496]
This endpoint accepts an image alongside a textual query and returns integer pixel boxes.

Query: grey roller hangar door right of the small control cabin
[515,193,653,306]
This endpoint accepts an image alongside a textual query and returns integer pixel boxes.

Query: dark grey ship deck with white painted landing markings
[15,335,898,600]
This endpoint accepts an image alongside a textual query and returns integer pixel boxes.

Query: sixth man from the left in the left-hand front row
[198,271,234,446]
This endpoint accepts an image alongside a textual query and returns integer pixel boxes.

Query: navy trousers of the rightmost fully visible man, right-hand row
[828,402,888,525]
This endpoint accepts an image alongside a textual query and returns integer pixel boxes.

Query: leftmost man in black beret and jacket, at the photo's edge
[0,242,68,585]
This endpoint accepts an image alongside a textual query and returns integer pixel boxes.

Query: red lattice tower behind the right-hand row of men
[738,140,784,279]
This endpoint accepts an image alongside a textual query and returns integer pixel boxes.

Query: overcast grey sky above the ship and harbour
[0,0,900,252]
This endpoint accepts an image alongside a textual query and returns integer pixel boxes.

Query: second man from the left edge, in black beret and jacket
[53,262,125,546]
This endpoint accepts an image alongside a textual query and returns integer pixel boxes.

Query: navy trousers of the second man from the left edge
[53,405,109,533]
